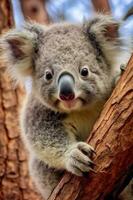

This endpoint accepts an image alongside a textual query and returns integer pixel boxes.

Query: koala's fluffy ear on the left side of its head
[0,26,41,80]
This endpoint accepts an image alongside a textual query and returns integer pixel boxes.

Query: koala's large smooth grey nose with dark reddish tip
[59,73,75,101]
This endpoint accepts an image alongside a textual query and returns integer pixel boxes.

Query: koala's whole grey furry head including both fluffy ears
[0,15,122,112]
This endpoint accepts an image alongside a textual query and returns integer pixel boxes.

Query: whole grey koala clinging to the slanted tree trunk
[0,14,131,199]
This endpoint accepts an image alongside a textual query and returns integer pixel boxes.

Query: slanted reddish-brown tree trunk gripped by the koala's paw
[49,56,133,200]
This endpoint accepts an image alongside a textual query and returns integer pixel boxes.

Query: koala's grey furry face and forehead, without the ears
[33,25,111,112]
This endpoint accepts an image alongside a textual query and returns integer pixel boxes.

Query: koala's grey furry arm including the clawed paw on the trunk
[21,96,93,175]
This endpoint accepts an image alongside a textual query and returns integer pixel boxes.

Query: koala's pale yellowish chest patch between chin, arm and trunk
[63,111,98,141]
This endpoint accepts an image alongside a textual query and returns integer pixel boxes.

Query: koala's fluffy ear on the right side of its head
[84,14,121,63]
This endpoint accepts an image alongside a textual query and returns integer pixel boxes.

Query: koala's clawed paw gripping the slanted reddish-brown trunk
[66,142,94,176]
